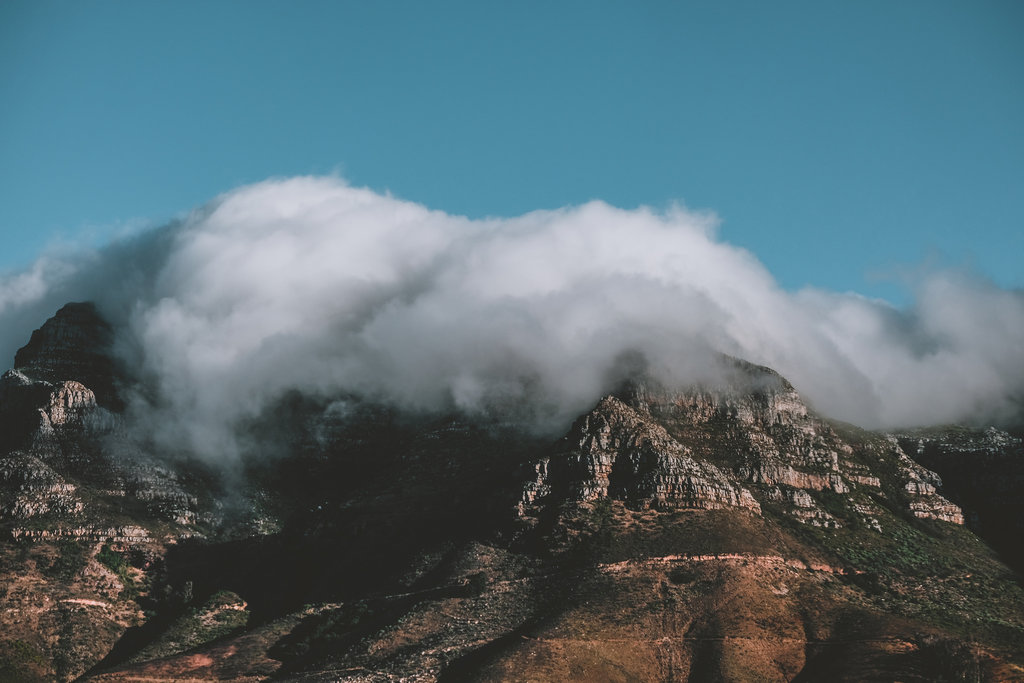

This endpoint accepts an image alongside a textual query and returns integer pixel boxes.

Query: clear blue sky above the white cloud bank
[0,0,1024,302]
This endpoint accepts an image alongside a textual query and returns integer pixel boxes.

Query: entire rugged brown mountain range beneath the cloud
[0,303,1024,681]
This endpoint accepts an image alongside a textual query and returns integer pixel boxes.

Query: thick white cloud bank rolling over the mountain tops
[0,177,1024,458]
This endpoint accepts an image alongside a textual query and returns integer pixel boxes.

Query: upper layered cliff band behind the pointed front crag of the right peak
[602,357,964,527]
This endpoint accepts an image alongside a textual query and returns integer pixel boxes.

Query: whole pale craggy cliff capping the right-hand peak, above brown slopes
[519,357,964,527]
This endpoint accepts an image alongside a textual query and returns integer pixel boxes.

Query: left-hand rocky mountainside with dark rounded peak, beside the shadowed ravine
[0,304,238,681]
